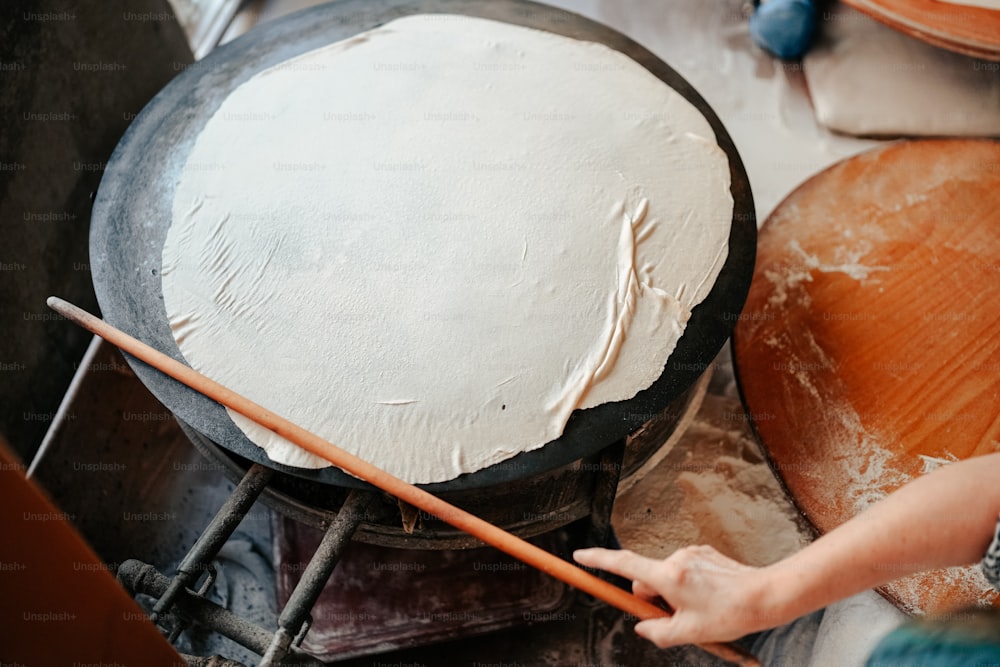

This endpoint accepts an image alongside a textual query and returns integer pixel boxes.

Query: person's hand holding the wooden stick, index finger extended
[573,546,791,648]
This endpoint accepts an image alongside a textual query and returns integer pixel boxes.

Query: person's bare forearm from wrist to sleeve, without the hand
[760,454,1000,620]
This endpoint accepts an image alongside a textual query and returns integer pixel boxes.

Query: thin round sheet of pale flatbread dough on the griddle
[162,15,732,483]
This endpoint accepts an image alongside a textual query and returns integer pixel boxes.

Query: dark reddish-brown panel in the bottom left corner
[0,438,185,667]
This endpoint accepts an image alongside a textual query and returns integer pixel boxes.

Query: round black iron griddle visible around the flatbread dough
[90,0,757,492]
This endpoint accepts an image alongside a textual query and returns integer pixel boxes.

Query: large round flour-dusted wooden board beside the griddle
[734,140,1000,612]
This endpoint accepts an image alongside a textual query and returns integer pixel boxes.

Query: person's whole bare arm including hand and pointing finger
[575,454,1000,647]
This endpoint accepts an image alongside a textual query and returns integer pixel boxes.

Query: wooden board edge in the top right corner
[845,0,1000,60]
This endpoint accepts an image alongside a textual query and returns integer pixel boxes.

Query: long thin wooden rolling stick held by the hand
[47,296,760,667]
